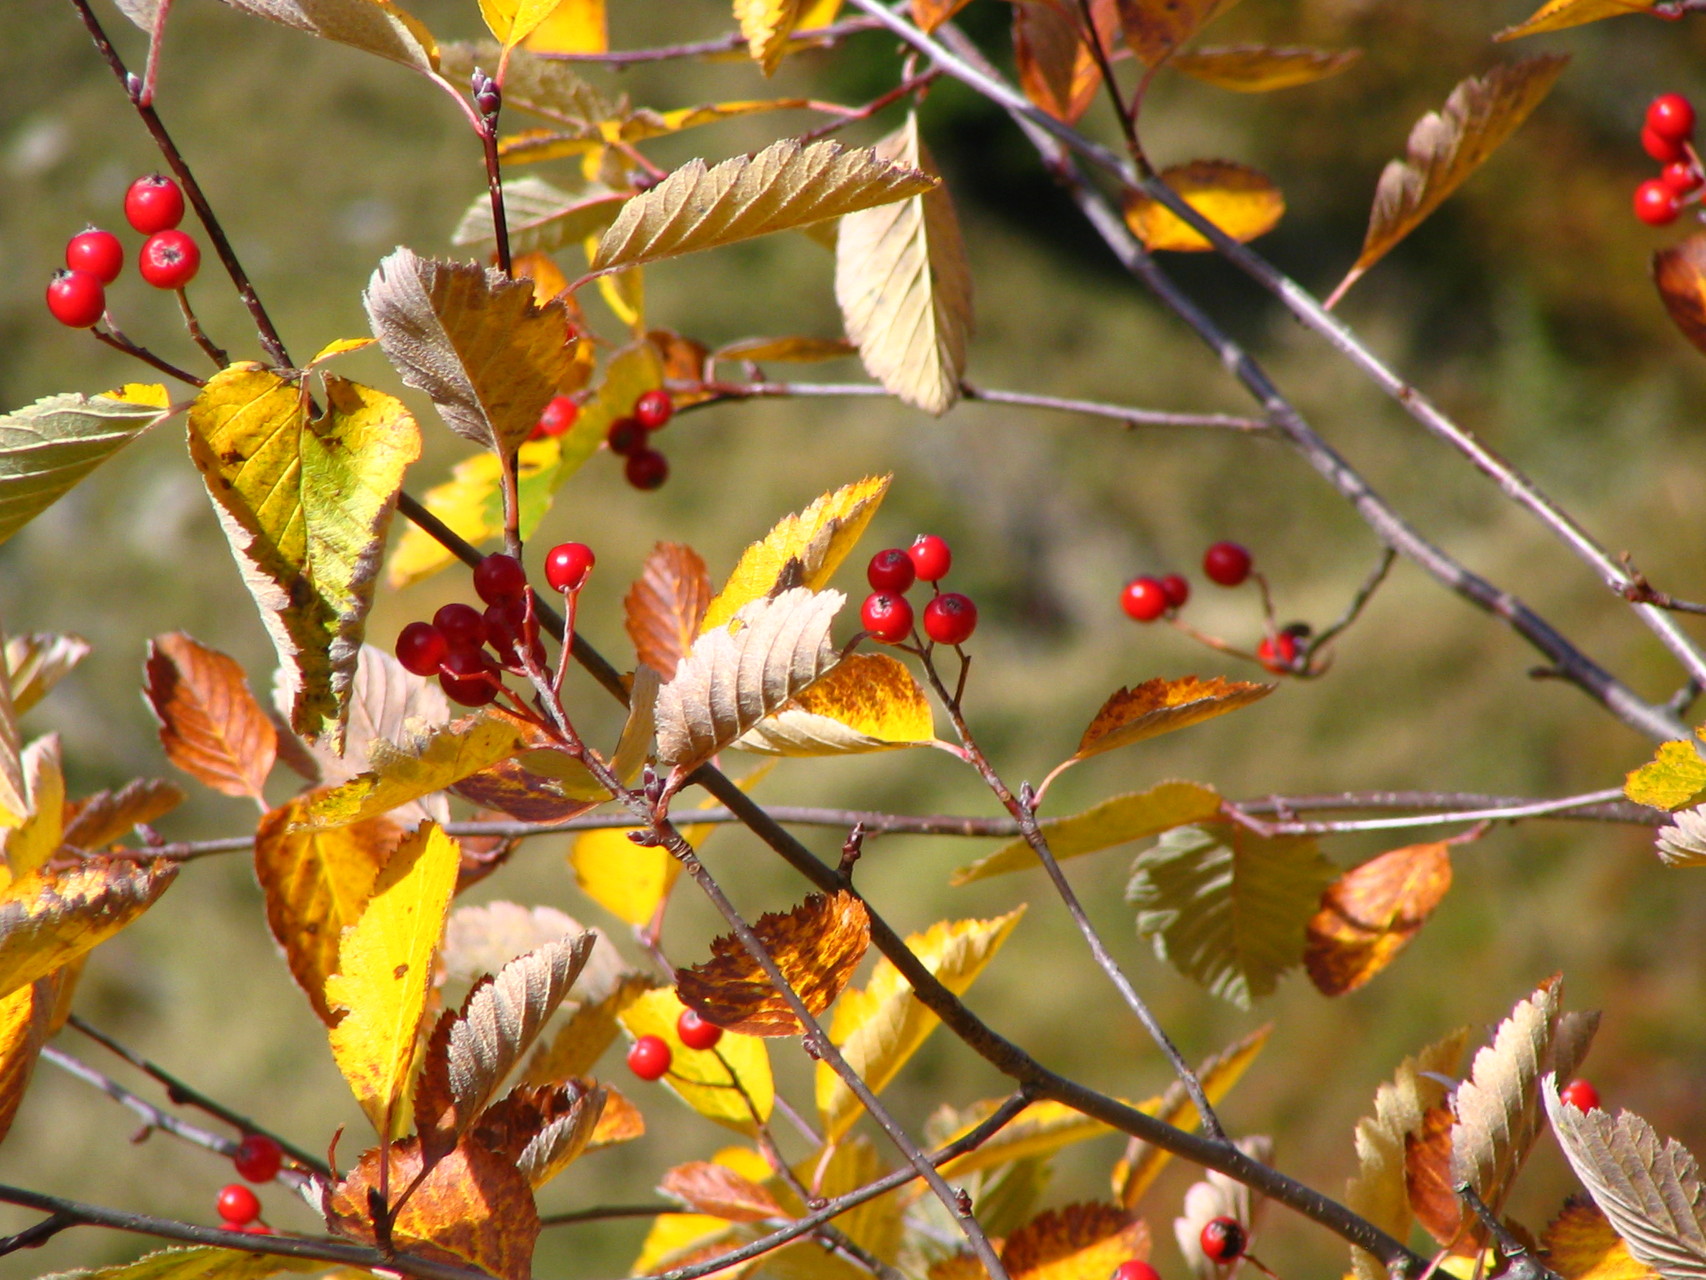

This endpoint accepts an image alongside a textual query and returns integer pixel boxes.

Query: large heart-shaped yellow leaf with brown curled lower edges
[189,364,421,749]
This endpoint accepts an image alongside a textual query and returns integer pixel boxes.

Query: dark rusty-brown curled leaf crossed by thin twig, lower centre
[676,893,870,1036]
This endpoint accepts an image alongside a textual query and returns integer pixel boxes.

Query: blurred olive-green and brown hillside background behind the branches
[0,0,1706,1277]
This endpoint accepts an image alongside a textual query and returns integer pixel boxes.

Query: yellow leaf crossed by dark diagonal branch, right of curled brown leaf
[817,906,1025,1140]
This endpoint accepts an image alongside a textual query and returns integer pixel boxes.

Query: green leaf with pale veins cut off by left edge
[0,387,169,543]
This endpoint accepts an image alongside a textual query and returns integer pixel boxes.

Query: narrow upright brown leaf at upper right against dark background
[1332,55,1570,299]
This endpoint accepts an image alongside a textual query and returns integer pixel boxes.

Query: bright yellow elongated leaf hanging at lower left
[326,823,462,1137]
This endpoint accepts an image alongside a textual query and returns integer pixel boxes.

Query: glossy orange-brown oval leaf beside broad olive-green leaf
[1303,841,1452,995]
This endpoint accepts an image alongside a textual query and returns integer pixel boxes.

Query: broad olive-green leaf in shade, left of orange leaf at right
[1126,826,1336,1009]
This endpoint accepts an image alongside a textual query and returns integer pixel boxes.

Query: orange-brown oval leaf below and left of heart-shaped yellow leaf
[143,631,278,800]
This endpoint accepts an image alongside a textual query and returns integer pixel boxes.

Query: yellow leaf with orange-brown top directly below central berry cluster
[735,654,937,756]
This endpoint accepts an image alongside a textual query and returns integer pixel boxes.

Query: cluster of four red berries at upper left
[48,174,201,329]
